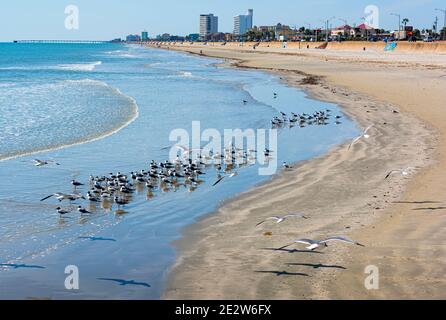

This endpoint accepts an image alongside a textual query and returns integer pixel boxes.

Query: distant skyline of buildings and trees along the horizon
[120,9,446,42]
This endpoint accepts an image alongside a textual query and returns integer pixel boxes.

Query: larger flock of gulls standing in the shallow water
[34,144,276,216]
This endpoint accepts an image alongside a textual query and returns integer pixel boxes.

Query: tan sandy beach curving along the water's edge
[153,43,446,299]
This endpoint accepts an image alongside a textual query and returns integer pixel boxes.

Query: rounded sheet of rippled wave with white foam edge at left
[0,79,139,161]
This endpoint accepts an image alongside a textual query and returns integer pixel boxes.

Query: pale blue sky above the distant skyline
[0,0,446,41]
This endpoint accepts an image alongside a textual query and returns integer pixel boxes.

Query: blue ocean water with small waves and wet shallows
[0,44,358,299]
